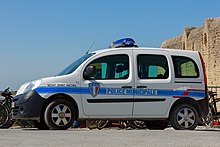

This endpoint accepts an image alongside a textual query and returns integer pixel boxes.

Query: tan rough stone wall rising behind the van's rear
[161,17,220,90]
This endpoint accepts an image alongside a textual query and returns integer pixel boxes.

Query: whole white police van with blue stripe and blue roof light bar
[13,38,208,130]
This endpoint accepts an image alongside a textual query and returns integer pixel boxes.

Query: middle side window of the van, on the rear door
[137,55,169,79]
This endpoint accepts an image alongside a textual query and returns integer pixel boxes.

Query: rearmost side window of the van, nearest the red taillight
[172,56,199,78]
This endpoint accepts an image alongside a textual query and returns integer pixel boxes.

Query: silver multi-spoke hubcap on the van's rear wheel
[177,108,195,128]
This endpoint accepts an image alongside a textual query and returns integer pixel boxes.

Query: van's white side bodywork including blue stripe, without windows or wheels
[14,48,208,119]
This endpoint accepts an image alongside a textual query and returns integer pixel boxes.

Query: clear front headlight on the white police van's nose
[16,80,41,95]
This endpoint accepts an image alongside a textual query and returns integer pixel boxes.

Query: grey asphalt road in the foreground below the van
[0,128,220,147]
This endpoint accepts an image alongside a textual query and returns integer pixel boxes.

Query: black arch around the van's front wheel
[40,93,79,119]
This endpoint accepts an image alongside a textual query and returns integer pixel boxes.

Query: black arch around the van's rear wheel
[169,97,201,118]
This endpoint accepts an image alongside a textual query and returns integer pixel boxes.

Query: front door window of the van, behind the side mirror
[84,54,129,80]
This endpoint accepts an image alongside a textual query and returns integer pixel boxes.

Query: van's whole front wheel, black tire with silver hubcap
[44,99,76,130]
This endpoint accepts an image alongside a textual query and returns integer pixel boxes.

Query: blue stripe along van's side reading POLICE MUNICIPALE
[35,87,205,98]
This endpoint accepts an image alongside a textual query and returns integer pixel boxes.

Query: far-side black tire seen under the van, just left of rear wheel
[145,120,168,130]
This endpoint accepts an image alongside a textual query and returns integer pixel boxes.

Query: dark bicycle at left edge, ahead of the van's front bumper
[0,87,14,129]
